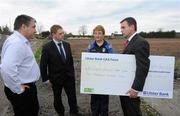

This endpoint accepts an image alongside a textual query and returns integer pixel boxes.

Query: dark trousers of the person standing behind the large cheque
[91,95,109,116]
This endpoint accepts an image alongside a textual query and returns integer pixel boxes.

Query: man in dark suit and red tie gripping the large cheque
[120,17,150,116]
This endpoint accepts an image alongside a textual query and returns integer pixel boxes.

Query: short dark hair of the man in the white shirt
[14,14,36,30]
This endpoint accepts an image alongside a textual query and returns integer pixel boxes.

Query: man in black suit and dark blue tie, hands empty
[40,25,82,116]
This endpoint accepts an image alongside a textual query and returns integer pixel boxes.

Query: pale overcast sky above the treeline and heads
[0,0,180,34]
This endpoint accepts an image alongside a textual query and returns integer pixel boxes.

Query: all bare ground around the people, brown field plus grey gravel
[0,39,180,116]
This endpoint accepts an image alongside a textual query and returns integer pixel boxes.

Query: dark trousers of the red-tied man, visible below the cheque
[120,96,142,116]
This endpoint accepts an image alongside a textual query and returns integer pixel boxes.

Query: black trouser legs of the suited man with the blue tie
[52,79,78,116]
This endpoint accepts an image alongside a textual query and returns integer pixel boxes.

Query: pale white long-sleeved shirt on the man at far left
[1,31,40,94]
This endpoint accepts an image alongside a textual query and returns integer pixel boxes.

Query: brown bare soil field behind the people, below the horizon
[68,38,180,59]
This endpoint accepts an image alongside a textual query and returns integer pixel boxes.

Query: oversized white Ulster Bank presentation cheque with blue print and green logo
[80,53,175,98]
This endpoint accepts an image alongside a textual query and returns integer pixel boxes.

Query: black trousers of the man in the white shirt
[4,84,39,116]
